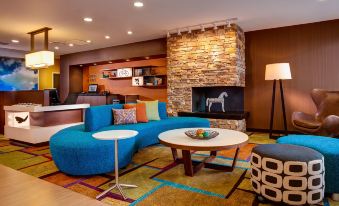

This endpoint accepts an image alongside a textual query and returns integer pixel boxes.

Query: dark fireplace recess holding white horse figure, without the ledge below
[192,86,244,113]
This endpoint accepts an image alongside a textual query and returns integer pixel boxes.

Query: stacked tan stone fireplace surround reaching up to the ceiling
[167,24,246,131]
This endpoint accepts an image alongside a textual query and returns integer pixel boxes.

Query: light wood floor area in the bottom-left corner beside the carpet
[0,165,105,206]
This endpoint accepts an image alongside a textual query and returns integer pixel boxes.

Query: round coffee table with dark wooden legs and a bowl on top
[159,128,248,177]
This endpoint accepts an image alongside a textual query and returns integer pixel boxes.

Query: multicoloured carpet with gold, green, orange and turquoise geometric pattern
[0,133,339,206]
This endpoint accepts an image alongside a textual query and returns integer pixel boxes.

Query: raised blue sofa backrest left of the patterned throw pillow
[85,104,123,132]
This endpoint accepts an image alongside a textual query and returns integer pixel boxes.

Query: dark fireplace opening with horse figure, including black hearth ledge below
[178,86,249,120]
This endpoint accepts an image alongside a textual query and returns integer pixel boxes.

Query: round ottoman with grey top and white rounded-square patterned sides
[251,144,325,205]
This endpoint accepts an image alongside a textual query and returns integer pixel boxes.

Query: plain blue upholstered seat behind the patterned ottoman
[277,135,339,193]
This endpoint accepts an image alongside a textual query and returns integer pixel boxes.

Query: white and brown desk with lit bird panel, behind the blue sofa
[4,104,90,144]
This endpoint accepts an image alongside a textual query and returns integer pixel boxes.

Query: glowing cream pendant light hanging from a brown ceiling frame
[25,27,54,69]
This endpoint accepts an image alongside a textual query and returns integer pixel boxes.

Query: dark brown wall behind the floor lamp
[245,20,339,130]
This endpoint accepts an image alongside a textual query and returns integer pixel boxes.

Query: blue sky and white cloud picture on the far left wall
[0,57,39,91]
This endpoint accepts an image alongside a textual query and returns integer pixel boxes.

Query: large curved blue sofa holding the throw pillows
[50,102,210,175]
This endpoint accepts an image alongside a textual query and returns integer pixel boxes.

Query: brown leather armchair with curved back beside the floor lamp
[292,89,339,137]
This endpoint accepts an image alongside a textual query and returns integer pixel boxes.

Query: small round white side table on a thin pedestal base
[92,130,138,200]
